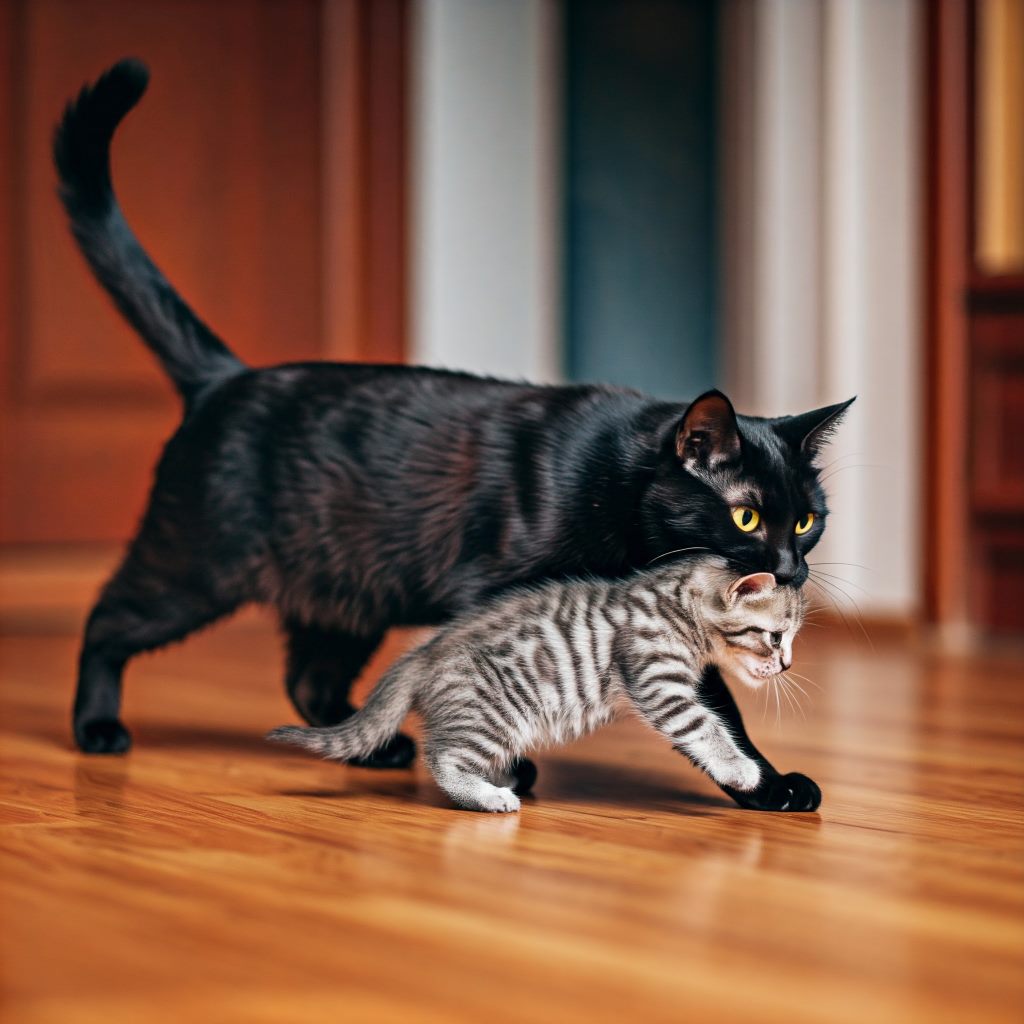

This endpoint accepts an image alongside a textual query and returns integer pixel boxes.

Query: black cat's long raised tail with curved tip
[53,59,246,407]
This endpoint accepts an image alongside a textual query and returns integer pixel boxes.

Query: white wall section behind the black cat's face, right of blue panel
[723,0,923,614]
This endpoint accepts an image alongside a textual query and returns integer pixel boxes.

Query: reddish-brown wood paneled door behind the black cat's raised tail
[0,0,406,544]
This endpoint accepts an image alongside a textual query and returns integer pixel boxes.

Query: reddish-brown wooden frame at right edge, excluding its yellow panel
[922,0,1024,631]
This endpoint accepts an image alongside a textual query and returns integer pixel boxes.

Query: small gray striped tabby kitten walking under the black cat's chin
[268,556,821,811]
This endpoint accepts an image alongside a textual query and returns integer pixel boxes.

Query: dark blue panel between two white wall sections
[564,0,718,397]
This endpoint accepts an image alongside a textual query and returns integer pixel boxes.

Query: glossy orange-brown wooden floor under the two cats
[0,598,1024,1024]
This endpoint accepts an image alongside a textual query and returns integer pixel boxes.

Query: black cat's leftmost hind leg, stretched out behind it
[73,554,238,754]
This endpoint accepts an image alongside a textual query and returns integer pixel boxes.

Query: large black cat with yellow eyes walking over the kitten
[54,60,852,802]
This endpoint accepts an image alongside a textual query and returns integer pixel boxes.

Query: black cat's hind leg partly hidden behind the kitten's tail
[285,622,416,768]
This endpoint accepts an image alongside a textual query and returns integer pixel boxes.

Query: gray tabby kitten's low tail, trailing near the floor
[266,651,422,761]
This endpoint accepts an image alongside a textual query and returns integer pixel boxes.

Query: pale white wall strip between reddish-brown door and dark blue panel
[411,0,561,381]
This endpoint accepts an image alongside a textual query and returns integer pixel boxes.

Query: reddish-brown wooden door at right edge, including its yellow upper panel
[923,0,1024,633]
